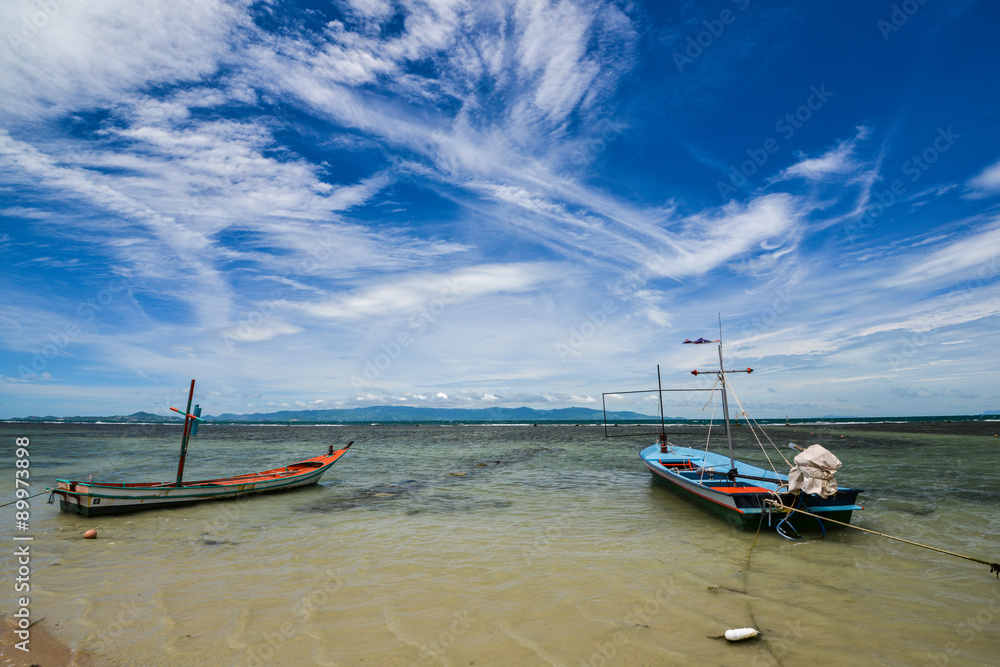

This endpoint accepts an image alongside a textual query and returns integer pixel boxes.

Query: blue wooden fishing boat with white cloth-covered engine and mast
[605,338,863,539]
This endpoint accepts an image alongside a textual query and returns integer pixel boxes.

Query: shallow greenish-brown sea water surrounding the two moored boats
[0,421,1000,666]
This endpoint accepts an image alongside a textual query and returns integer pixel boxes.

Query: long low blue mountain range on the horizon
[10,405,654,423]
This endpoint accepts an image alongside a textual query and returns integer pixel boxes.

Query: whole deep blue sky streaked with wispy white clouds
[0,0,1000,417]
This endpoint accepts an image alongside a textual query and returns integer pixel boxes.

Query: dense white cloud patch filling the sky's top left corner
[0,0,251,120]
